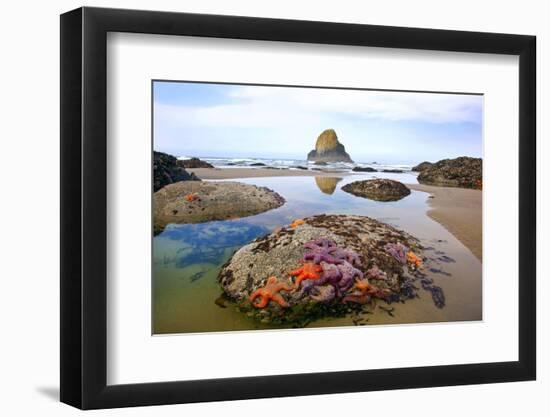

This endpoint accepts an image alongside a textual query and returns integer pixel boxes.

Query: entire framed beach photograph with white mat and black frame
[61,7,536,409]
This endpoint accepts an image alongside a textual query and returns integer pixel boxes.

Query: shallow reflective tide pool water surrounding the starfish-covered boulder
[152,173,482,334]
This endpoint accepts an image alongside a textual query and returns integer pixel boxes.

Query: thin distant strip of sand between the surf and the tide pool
[187,168,350,180]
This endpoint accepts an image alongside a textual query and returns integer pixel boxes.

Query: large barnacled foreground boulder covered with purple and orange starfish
[218,215,438,326]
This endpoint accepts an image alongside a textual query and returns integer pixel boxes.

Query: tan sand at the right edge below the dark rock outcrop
[407,184,483,261]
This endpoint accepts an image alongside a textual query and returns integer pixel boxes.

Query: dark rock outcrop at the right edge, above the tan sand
[417,156,483,189]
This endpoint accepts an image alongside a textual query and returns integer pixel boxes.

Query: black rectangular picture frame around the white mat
[60,7,536,409]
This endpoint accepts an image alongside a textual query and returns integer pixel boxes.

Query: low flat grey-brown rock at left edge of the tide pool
[153,181,285,234]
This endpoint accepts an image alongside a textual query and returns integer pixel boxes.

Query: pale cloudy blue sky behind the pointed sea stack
[154,81,483,163]
